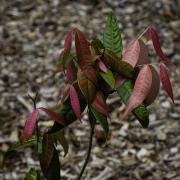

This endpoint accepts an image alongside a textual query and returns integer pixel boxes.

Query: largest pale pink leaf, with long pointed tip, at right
[120,65,152,120]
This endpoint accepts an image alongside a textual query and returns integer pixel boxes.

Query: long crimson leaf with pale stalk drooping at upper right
[140,25,173,67]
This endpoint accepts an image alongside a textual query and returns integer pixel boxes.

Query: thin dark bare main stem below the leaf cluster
[77,120,96,180]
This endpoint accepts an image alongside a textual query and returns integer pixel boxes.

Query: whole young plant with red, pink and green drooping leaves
[10,14,174,180]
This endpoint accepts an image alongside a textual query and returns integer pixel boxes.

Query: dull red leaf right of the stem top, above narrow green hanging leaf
[92,91,109,117]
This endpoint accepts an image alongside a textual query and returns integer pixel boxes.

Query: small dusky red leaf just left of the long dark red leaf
[66,60,77,84]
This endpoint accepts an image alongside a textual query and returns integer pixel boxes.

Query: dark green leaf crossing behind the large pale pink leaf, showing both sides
[117,80,149,128]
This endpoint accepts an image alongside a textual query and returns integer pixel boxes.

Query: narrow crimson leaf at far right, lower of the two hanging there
[160,64,174,102]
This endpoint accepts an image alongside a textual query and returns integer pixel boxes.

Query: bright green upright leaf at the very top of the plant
[103,13,122,58]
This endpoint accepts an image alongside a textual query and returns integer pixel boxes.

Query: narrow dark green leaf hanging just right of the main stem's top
[90,107,109,139]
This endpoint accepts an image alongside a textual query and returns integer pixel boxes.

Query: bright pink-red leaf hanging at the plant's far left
[22,109,39,141]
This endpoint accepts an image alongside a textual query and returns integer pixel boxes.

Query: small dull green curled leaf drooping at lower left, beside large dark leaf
[53,129,69,157]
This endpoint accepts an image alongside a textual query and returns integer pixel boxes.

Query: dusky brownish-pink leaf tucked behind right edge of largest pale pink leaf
[144,65,160,106]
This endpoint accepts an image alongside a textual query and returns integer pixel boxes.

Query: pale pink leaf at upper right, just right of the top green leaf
[123,40,140,67]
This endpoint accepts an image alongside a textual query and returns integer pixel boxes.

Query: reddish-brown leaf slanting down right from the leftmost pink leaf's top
[38,107,65,125]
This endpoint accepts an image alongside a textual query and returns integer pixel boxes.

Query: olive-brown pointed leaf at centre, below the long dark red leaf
[78,71,96,104]
